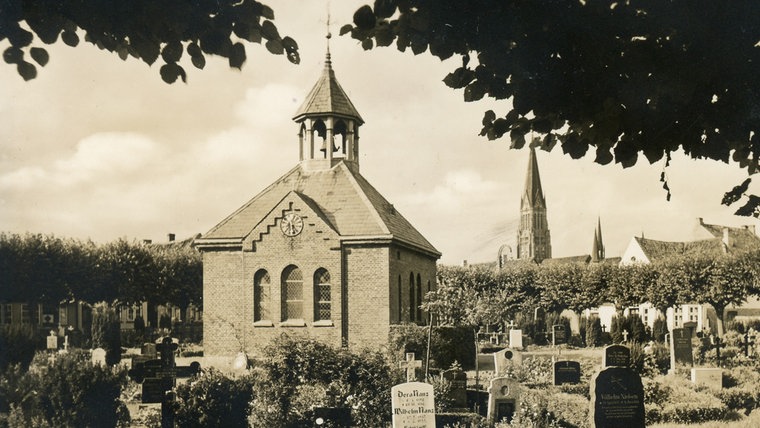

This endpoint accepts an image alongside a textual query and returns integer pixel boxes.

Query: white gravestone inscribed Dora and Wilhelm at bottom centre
[391,382,435,428]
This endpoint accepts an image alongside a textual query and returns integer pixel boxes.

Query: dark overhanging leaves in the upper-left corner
[0,0,299,83]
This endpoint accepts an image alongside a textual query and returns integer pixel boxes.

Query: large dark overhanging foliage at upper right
[341,0,760,217]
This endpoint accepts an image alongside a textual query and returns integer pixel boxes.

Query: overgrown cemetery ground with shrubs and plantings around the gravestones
[0,327,760,428]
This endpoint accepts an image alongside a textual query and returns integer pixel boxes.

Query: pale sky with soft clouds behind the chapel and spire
[0,0,760,264]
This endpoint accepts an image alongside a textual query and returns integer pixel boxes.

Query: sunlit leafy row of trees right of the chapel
[424,251,760,334]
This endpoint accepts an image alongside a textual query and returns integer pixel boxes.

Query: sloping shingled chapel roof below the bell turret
[199,160,441,256]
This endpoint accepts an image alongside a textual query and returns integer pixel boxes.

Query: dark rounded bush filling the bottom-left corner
[0,351,129,428]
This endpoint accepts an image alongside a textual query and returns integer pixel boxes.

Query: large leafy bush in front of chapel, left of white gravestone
[251,336,400,428]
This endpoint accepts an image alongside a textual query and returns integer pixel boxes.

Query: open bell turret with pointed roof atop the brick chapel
[293,32,364,172]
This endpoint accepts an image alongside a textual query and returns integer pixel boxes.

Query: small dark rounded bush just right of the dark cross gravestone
[174,368,254,427]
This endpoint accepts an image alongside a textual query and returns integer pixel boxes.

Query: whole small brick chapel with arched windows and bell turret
[195,49,441,355]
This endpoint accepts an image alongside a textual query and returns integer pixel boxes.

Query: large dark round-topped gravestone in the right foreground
[589,367,645,428]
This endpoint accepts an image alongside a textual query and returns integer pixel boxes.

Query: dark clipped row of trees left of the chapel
[0,233,203,310]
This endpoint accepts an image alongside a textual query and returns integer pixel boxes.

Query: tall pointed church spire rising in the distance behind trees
[517,147,552,263]
